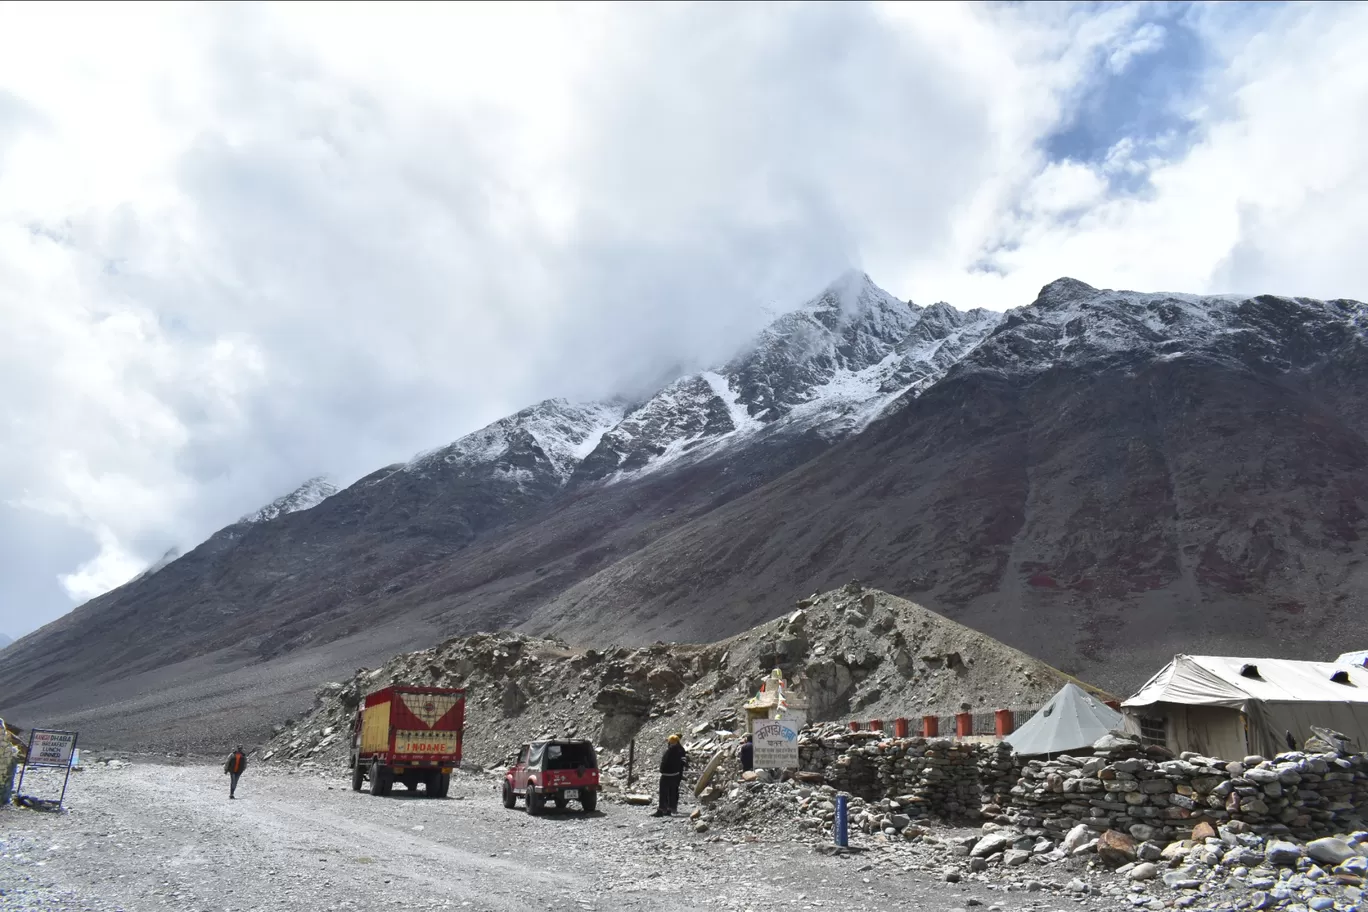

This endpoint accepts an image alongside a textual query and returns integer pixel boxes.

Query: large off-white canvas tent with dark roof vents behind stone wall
[1122,655,1368,760]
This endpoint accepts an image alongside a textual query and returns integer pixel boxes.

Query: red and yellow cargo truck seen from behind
[352,684,465,799]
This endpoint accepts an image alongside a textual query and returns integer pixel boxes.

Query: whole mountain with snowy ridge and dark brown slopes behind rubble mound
[0,275,1368,749]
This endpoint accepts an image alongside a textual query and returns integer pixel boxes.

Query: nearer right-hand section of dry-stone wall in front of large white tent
[996,736,1368,844]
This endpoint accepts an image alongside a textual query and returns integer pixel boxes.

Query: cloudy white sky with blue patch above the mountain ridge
[0,3,1368,636]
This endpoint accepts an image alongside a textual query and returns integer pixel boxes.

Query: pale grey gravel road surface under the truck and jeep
[0,762,1028,912]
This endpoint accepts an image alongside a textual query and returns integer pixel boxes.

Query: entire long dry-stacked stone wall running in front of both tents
[799,727,1368,842]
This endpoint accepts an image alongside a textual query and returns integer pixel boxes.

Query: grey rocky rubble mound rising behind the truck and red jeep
[259,582,1107,777]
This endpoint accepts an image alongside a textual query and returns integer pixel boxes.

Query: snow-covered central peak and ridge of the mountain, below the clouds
[367,272,1003,489]
